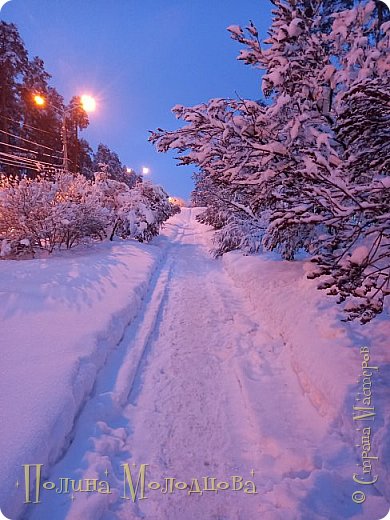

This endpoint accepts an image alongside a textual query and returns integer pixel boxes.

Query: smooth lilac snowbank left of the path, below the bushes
[0,242,162,517]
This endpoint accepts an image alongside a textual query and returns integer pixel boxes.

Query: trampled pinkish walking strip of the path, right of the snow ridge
[110,209,338,520]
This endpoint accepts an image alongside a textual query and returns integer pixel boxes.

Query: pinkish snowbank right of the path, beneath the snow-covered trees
[222,252,390,518]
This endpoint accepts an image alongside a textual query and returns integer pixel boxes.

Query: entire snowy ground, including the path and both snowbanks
[0,210,390,520]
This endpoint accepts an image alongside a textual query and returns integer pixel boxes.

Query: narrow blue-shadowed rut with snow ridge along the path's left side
[23,213,190,520]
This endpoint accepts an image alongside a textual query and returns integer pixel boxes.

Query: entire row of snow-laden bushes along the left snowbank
[0,171,180,257]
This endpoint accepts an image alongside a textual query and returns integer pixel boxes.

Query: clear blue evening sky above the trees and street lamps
[1,0,272,197]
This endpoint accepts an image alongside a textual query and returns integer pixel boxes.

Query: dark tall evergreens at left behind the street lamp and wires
[0,22,99,176]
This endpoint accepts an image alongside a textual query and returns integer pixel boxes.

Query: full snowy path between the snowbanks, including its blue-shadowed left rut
[27,210,356,520]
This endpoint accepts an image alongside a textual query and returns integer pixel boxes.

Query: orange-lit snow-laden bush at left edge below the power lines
[0,173,109,256]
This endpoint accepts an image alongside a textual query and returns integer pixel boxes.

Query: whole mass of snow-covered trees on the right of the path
[151,0,390,321]
